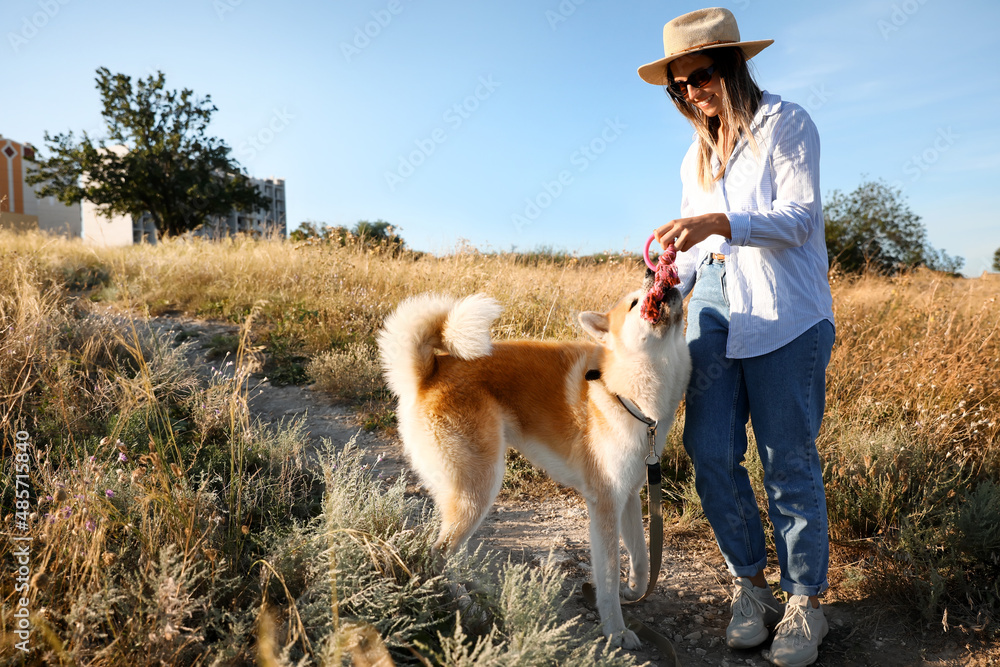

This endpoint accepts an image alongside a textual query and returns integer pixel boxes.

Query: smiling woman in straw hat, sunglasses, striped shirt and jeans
[639,9,834,666]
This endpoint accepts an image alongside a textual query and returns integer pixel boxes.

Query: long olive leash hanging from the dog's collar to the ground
[582,386,681,667]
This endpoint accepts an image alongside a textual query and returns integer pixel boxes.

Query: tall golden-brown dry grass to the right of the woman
[819,271,1000,633]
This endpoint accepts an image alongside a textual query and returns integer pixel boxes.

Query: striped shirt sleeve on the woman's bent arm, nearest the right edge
[726,107,823,248]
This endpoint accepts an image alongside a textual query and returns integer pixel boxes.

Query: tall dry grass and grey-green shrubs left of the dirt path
[0,235,635,667]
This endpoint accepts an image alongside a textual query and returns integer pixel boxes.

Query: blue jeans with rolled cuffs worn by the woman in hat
[684,260,834,595]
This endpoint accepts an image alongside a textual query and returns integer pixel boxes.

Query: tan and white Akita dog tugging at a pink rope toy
[378,272,691,649]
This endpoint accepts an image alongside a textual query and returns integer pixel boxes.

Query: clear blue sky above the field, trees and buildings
[0,0,1000,275]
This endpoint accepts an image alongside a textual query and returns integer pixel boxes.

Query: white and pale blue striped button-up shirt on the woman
[677,91,833,359]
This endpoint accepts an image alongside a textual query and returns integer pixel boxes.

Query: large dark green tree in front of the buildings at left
[27,67,267,236]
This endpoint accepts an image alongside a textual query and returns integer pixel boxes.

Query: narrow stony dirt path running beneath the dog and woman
[156,317,1000,667]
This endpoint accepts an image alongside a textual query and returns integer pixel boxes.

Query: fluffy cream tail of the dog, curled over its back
[378,294,502,396]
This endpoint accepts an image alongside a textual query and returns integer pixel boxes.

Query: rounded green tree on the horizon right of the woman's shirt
[823,180,965,273]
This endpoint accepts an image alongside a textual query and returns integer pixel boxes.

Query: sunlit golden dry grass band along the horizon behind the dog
[0,234,641,350]
